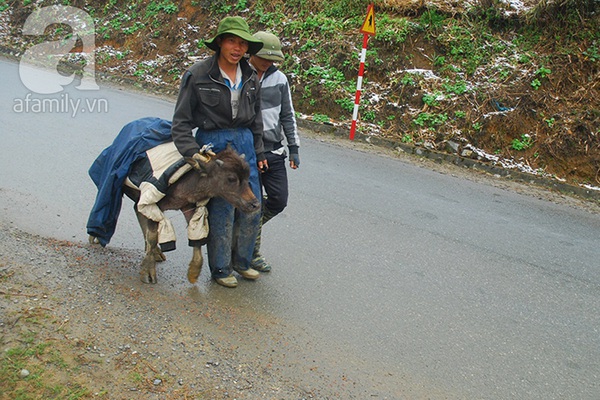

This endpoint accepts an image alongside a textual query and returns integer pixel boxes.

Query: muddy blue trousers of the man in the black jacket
[196,128,261,279]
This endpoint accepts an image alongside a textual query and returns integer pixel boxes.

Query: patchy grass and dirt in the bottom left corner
[0,262,202,400]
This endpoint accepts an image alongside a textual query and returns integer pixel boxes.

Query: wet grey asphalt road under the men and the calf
[0,60,600,399]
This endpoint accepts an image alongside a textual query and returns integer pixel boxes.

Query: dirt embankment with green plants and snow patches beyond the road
[0,0,600,187]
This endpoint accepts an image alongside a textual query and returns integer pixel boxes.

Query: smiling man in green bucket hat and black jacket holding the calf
[171,17,268,287]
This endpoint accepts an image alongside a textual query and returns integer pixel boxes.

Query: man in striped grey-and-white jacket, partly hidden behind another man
[250,31,300,272]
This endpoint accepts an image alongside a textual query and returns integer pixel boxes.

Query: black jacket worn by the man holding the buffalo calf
[171,53,265,161]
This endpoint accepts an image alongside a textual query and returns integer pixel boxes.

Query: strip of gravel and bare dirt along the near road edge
[0,221,318,399]
